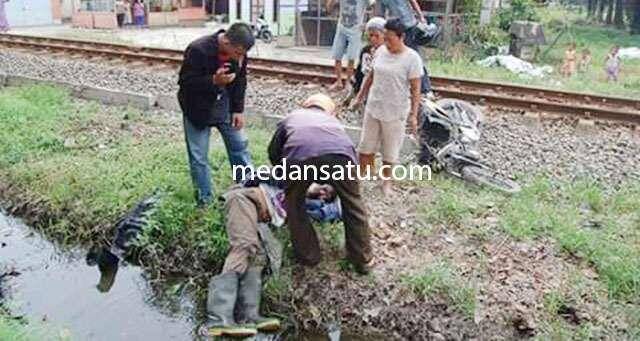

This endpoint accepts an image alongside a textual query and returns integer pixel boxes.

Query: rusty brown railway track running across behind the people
[0,34,640,125]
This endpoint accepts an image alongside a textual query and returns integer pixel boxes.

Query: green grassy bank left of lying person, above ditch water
[0,86,267,275]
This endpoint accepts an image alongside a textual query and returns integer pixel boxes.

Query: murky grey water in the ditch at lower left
[0,213,197,340]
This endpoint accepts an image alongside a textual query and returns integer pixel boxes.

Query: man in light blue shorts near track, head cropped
[327,0,369,90]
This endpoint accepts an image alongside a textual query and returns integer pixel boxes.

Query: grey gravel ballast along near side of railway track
[0,51,640,185]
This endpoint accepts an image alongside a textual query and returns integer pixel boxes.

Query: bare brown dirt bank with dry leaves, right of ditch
[272,179,626,340]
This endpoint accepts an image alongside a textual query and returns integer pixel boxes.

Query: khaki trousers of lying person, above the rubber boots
[222,186,267,273]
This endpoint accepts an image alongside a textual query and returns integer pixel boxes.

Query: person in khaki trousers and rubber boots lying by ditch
[201,181,341,337]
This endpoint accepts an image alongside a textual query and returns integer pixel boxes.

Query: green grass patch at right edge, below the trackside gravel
[501,179,640,300]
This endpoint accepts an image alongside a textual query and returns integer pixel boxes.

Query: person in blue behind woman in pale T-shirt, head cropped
[375,0,431,94]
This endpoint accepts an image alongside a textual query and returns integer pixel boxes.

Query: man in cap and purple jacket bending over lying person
[268,94,373,274]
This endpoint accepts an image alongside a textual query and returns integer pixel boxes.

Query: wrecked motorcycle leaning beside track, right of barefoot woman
[418,98,520,193]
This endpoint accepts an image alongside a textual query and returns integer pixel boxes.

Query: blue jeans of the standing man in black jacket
[183,105,252,205]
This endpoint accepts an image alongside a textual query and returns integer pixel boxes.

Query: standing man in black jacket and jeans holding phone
[178,23,255,207]
